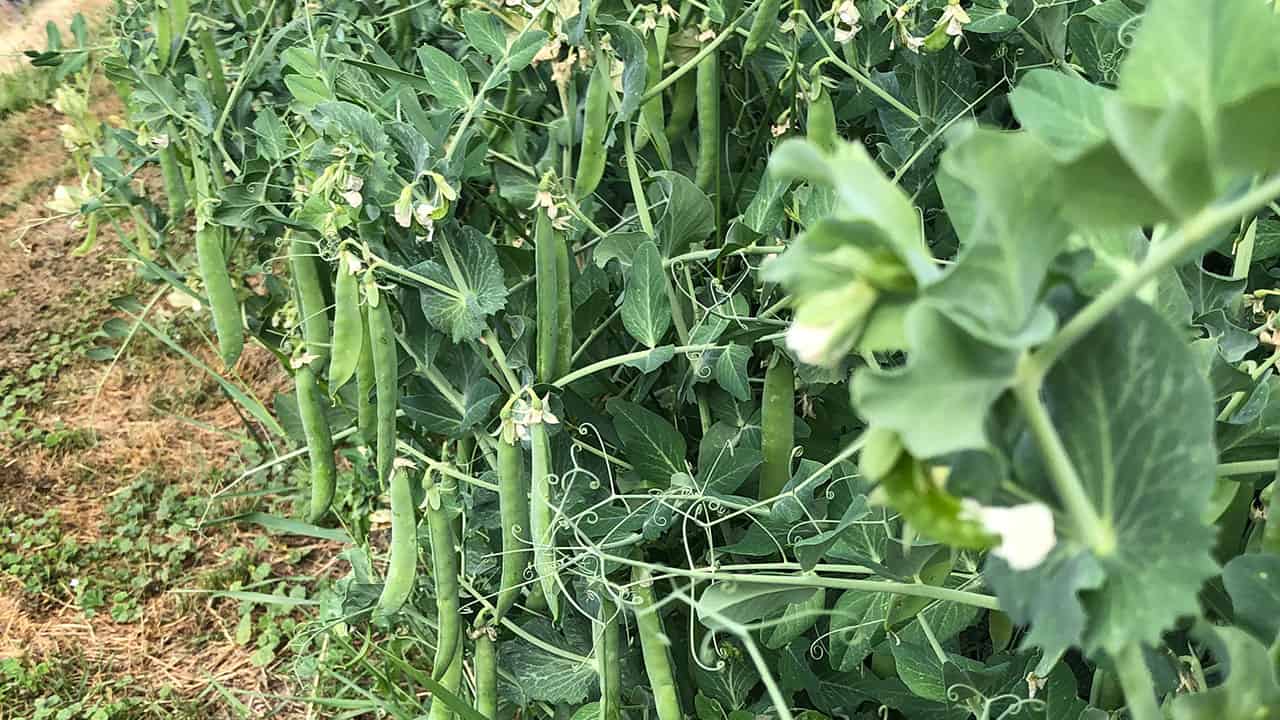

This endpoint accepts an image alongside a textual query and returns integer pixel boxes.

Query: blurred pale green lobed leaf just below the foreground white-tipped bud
[852,302,1018,459]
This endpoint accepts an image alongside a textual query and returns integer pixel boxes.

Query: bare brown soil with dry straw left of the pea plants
[0,0,325,719]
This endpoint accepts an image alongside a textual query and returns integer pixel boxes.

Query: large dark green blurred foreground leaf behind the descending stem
[988,301,1217,653]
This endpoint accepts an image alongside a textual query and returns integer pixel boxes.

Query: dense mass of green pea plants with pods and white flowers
[60,0,1280,720]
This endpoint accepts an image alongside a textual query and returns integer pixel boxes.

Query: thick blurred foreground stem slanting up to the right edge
[1027,176,1280,386]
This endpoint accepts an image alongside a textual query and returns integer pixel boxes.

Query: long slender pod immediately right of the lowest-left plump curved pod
[422,471,462,681]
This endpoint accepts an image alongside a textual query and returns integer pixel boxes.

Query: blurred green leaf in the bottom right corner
[1170,625,1280,720]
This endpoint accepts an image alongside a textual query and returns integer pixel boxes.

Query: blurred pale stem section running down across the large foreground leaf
[1014,373,1115,555]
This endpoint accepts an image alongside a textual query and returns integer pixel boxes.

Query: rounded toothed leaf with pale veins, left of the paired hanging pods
[412,228,507,342]
